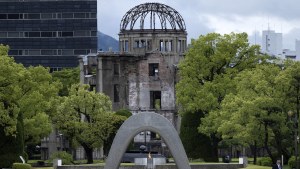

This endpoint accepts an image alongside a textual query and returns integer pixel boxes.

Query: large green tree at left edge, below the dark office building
[0,45,60,167]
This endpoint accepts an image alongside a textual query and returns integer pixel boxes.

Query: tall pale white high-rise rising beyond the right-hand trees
[261,30,284,59]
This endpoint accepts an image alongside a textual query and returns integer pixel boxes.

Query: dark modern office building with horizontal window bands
[0,0,97,70]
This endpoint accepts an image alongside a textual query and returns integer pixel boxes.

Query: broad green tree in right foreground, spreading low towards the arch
[200,64,290,162]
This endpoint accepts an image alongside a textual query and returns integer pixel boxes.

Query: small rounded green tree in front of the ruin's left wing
[53,85,118,163]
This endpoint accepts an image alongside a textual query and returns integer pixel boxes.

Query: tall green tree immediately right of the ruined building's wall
[176,33,264,161]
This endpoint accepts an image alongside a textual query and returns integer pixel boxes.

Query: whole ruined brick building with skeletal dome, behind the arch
[80,3,187,149]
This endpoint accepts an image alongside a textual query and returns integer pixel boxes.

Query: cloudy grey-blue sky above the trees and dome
[98,0,300,50]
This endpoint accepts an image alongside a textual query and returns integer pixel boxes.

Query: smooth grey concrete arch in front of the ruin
[104,113,191,169]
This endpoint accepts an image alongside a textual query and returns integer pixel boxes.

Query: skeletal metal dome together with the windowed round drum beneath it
[119,3,187,54]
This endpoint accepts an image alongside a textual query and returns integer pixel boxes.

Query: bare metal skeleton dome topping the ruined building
[120,3,186,31]
